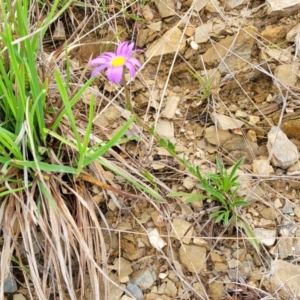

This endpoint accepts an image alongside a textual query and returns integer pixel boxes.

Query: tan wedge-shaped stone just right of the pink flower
[145,27,186,58]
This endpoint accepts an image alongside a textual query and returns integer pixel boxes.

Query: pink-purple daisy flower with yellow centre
[88,42,141,83]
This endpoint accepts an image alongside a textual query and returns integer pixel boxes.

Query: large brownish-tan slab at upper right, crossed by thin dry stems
[203,26,256,74]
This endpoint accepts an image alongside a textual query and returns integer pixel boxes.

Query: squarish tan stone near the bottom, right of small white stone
[179,245,206,274]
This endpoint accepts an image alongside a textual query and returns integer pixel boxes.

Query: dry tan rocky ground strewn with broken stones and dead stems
[4,0,300,300]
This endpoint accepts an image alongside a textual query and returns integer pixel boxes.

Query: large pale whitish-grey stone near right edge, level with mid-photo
[267,126,299,169]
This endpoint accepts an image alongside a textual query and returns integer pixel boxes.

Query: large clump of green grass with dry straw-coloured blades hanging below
[0,0,162,300]
